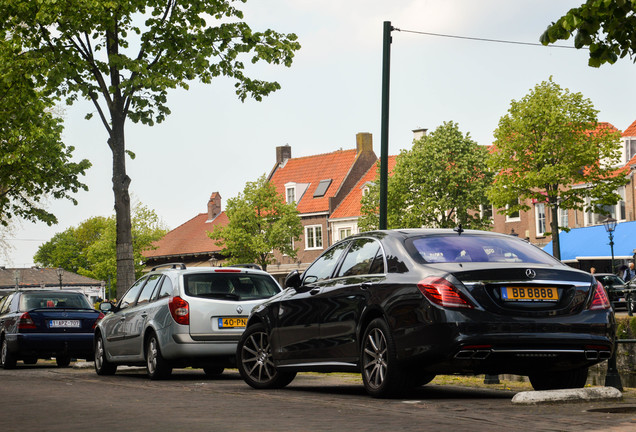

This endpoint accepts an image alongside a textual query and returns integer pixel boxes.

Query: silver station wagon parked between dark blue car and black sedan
[95,264,281,379]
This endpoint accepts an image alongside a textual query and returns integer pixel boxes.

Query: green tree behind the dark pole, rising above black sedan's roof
[359,121,492,231]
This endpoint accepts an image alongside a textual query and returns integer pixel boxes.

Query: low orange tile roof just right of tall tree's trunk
[143,212,229,258]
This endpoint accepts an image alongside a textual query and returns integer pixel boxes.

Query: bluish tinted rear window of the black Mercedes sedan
[409,234,556,264]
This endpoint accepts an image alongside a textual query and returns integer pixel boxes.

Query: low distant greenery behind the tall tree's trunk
[33,204,168,290]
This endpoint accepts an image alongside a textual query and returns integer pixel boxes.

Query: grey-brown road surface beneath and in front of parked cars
[0,363,636,432]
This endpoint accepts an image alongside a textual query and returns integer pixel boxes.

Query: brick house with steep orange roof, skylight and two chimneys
[267,133,377,280]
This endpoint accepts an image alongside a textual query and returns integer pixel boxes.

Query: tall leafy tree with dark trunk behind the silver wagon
[0,0,300,295]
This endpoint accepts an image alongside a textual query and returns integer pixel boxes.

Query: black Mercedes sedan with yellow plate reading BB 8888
[237,228,615,397]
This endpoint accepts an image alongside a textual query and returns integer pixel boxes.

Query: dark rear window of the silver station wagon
[183,273,280,300]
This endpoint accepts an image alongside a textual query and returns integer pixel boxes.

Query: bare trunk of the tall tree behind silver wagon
[109,115,135,299]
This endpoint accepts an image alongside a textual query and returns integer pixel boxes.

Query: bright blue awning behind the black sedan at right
[543,221,636,262]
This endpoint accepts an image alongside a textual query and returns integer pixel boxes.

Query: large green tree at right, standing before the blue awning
[488,78,627,258]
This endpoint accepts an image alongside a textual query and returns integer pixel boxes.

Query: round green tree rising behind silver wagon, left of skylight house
[209,175,303,270]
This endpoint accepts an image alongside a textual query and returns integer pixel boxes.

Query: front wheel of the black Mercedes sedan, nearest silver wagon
[236,323,296,389]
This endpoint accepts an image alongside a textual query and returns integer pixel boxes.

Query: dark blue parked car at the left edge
[0,290,104,369]
